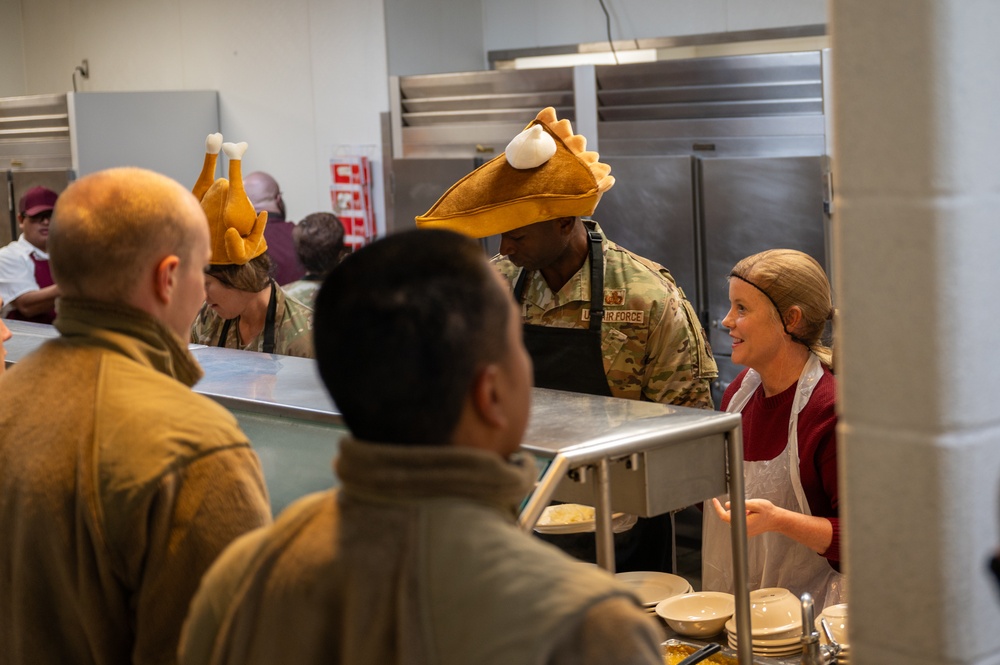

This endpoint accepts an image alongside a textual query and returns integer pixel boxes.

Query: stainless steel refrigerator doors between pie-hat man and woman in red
[594,155,828,406]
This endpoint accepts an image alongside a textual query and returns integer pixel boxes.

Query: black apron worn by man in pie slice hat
[514,228,611,397]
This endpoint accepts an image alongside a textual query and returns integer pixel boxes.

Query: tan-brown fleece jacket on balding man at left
[0,298,271,665]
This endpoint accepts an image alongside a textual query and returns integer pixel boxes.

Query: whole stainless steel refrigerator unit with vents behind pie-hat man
[385,51,831,403]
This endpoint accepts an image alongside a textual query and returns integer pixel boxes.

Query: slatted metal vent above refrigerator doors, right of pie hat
[596,51,823,122]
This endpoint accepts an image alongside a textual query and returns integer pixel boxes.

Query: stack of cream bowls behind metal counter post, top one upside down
[726,587,802,658]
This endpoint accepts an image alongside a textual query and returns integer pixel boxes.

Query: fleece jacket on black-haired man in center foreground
[180,440,662,665]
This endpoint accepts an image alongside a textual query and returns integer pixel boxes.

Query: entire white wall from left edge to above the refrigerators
[0,0,827,231]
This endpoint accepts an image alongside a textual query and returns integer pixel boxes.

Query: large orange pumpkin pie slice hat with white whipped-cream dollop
[416,106,615,238]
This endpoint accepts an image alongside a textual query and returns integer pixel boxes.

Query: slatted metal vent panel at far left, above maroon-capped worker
[0,95,72,169]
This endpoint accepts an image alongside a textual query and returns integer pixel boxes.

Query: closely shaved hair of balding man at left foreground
[48,167,207,302]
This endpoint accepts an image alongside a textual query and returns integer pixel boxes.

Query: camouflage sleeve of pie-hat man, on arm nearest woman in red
[643,293,719,409]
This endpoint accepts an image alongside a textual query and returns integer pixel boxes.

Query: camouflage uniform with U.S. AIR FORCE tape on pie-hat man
[493,220,719,409]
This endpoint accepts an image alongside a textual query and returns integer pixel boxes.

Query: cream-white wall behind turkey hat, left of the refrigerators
[0,0,388,228]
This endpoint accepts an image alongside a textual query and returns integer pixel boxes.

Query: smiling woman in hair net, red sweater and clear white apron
[702,249,846,609]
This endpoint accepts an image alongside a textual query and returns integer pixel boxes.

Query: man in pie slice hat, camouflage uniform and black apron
[416,107,718,570]
